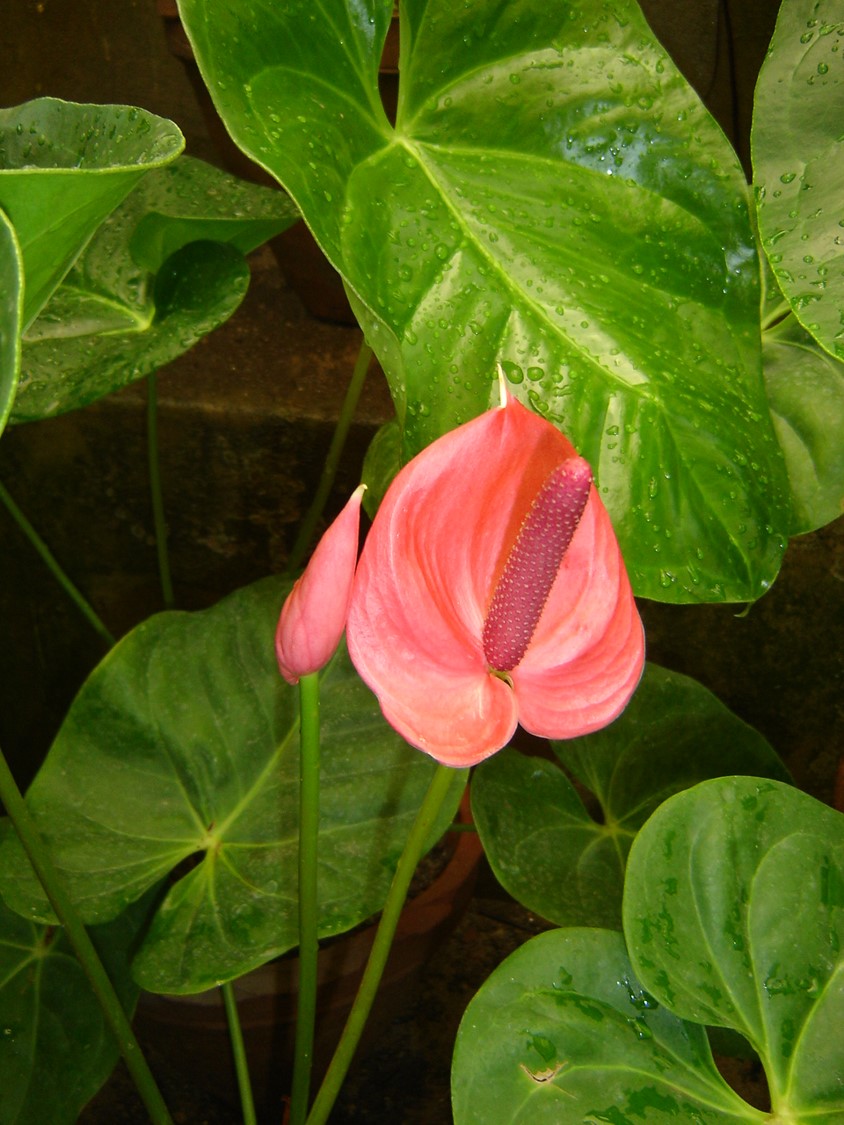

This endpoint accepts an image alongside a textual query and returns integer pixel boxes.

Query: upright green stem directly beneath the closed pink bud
[289,673,320,1125]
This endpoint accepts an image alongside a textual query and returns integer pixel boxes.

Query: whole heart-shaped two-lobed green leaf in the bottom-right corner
[452,777,844,1125]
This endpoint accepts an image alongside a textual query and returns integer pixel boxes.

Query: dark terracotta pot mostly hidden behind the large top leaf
[156,0,398,325]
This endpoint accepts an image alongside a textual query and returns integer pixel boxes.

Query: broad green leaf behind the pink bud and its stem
[0,579,466,992]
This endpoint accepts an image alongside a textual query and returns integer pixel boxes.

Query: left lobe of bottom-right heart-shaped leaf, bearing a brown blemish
[451,929,765,1125]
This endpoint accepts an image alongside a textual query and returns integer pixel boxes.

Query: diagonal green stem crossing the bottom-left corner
[0,752,172,1125]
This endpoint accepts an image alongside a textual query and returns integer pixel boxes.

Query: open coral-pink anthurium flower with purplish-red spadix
[347,398,644,766]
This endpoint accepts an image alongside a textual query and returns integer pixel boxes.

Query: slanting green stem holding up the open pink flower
[307,766,454,1125]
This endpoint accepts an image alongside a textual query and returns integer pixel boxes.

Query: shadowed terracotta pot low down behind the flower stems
[135,799,483,1121]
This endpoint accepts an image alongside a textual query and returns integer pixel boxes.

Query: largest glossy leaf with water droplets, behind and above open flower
[180,0,790,602]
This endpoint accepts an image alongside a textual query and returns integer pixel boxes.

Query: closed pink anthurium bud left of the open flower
[276,485,366,684]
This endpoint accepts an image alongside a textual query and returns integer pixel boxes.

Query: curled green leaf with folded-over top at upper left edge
[0,98,185,327]
